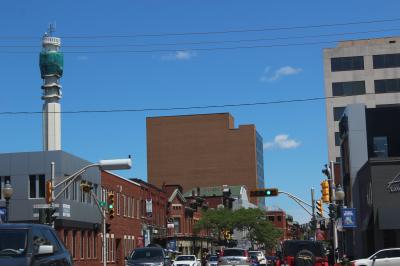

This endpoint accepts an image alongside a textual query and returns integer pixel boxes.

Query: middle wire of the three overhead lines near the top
[0,28,400,48]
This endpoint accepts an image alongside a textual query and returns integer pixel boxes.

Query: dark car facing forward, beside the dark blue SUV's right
[125,247,171,266]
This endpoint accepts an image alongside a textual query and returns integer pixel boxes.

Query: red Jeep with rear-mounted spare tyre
[281,240,329,266]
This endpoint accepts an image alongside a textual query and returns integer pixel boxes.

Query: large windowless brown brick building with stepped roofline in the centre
[147,113,264,206]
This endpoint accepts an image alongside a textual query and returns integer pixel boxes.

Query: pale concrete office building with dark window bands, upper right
[324,37,400,161]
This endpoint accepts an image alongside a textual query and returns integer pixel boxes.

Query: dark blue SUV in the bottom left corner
[0,223,73,266]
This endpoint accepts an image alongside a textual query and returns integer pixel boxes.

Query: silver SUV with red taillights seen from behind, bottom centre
[218,248,252,266]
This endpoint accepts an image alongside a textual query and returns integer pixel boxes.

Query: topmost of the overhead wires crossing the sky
[0,18,400,40]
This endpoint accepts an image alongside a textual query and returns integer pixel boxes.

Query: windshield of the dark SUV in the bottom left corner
[0,229,28,256]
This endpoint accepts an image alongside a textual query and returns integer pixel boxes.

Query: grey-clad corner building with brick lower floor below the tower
[0,151,101,265]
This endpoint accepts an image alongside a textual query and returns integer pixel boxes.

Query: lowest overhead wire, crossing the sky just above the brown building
[0,93,375,115]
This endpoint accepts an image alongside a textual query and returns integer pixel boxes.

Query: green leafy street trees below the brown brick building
[195,208,282,249]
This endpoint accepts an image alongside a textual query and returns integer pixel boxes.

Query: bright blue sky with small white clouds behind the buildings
[0,0,400,222]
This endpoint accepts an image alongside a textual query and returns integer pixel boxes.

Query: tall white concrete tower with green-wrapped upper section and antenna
[39,24,64,151]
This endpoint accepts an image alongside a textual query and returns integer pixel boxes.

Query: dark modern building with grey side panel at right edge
[339,104,400,257]
